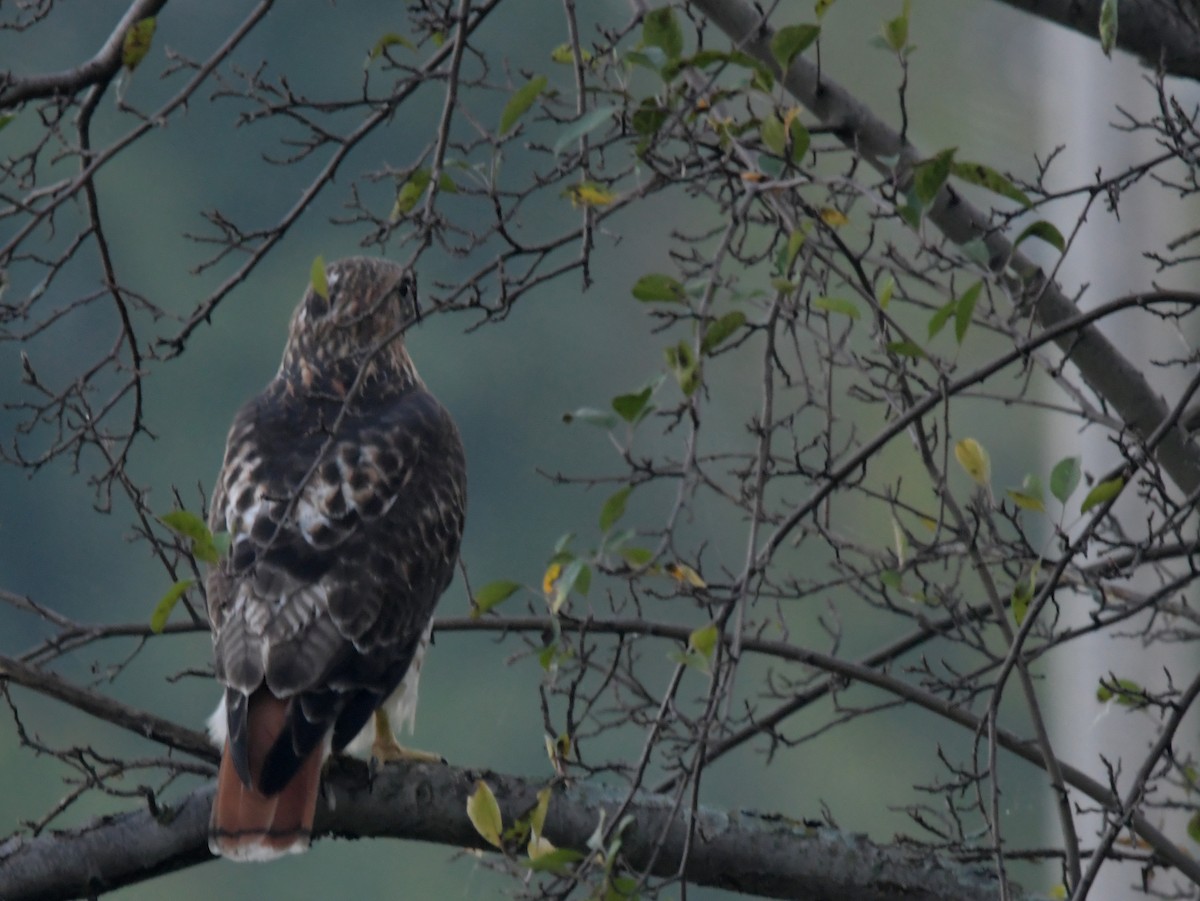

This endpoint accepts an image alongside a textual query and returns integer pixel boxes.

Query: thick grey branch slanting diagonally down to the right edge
[691,0,1200,494]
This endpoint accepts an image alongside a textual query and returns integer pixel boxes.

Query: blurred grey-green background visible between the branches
[0,0,1166,901]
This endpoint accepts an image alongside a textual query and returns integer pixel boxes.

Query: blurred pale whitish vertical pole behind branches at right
[1030,19,1192,901]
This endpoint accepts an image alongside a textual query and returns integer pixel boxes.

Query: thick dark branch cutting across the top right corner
[1000,0,1200,79]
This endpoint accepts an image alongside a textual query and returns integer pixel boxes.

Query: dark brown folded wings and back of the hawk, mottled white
[208,380,466,795]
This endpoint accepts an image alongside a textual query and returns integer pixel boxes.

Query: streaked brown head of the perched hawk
[280,257,418,391]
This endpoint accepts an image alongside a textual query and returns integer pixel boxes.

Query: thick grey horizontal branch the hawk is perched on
[0,761,1012,901]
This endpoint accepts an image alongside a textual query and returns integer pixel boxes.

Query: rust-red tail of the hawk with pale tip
[209,689,323,860]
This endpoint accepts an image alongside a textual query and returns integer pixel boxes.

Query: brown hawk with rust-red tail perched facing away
[201,258,467,860]
